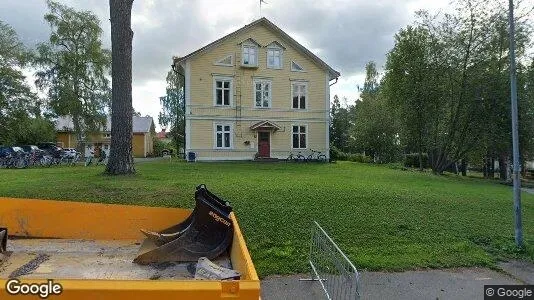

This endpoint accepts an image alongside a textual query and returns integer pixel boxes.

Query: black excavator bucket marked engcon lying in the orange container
[134,184,234,265]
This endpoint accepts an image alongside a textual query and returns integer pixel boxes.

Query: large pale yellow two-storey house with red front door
[174,18,340,160]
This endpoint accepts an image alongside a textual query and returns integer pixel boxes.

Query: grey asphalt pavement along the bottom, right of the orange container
[261,262,534,300]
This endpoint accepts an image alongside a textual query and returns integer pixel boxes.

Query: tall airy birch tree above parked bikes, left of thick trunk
[36,1,111,148]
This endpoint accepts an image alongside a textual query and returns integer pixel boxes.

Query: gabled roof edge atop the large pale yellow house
[173,17,341,80]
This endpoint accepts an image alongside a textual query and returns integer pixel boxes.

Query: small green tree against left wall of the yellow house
[158,70,185,156]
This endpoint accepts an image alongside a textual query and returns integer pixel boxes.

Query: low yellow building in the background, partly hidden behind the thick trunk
[56,116,155,157]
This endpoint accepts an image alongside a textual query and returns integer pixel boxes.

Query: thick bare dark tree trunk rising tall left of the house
[106,0,135,175]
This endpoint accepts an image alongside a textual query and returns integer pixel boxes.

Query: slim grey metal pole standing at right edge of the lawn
[508,0,523,247]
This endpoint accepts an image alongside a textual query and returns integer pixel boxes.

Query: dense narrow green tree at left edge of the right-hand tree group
[383,26,442,170]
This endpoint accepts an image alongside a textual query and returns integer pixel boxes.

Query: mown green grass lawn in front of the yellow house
[0,161,534,276]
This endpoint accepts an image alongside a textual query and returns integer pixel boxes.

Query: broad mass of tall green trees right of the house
[383,0,534,174]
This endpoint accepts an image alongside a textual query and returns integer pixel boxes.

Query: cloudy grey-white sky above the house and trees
[0,0,448,128]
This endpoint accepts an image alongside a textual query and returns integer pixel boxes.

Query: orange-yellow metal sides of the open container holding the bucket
[0,197,260,300]
